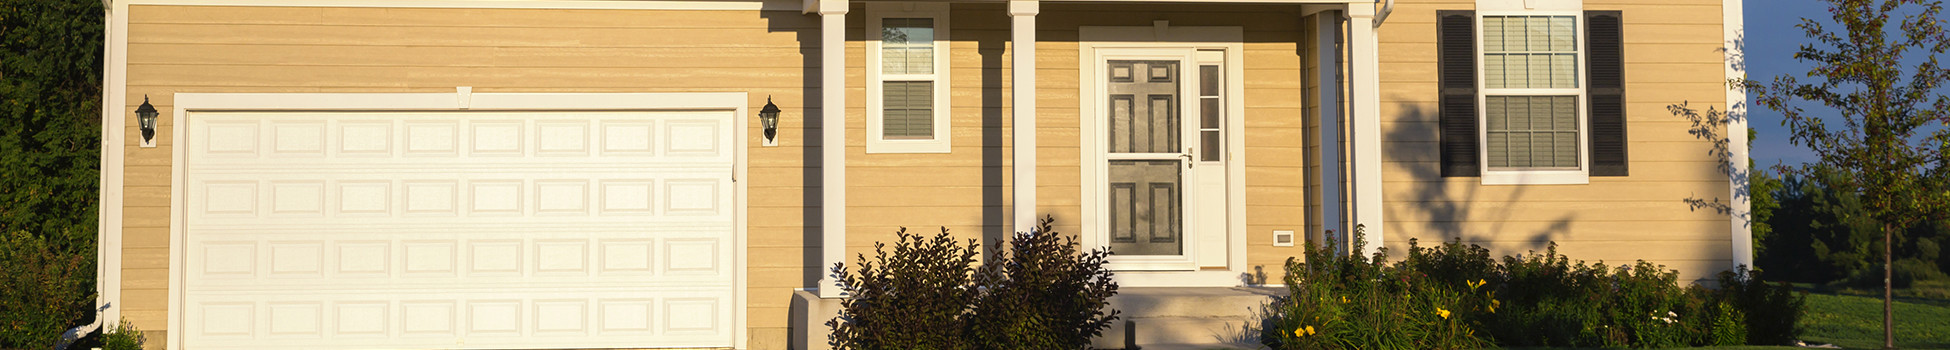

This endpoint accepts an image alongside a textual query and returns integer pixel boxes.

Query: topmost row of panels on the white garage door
[189,111,733,166]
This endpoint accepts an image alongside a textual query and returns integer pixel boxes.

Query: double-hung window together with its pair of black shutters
[1437,6,1630,184]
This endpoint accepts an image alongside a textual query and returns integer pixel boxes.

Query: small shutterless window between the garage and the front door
[866,2,950,153]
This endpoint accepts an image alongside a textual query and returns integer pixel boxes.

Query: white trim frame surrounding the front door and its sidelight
[1078,22,1246,287]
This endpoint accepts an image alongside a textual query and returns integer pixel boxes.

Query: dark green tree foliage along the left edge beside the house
[0,0,103,348]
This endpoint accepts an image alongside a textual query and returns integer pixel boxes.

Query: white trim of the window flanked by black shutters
[1474,8,1591,186]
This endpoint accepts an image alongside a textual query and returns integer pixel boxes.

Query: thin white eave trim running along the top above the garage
[115,0,801,12]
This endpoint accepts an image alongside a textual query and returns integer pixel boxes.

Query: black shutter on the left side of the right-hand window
[1435,10,1482,178]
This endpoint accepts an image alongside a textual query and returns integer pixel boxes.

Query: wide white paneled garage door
[181,111,739,348]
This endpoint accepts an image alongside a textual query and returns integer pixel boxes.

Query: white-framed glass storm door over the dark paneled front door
[1102,55,1197,262]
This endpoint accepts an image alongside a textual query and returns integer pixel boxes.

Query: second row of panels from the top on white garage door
[191,170,733,219]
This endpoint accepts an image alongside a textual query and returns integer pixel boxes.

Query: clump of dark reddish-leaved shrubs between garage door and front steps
[827,219,1117,350]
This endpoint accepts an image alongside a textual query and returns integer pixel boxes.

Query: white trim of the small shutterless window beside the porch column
[866,2,952,153]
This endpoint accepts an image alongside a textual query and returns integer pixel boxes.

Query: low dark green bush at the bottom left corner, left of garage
[0,231,96,348]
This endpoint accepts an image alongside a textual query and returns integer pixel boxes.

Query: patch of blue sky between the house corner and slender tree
[1747,0,1827,166]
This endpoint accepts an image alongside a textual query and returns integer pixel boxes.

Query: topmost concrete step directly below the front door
[1110,287,1287,319]
